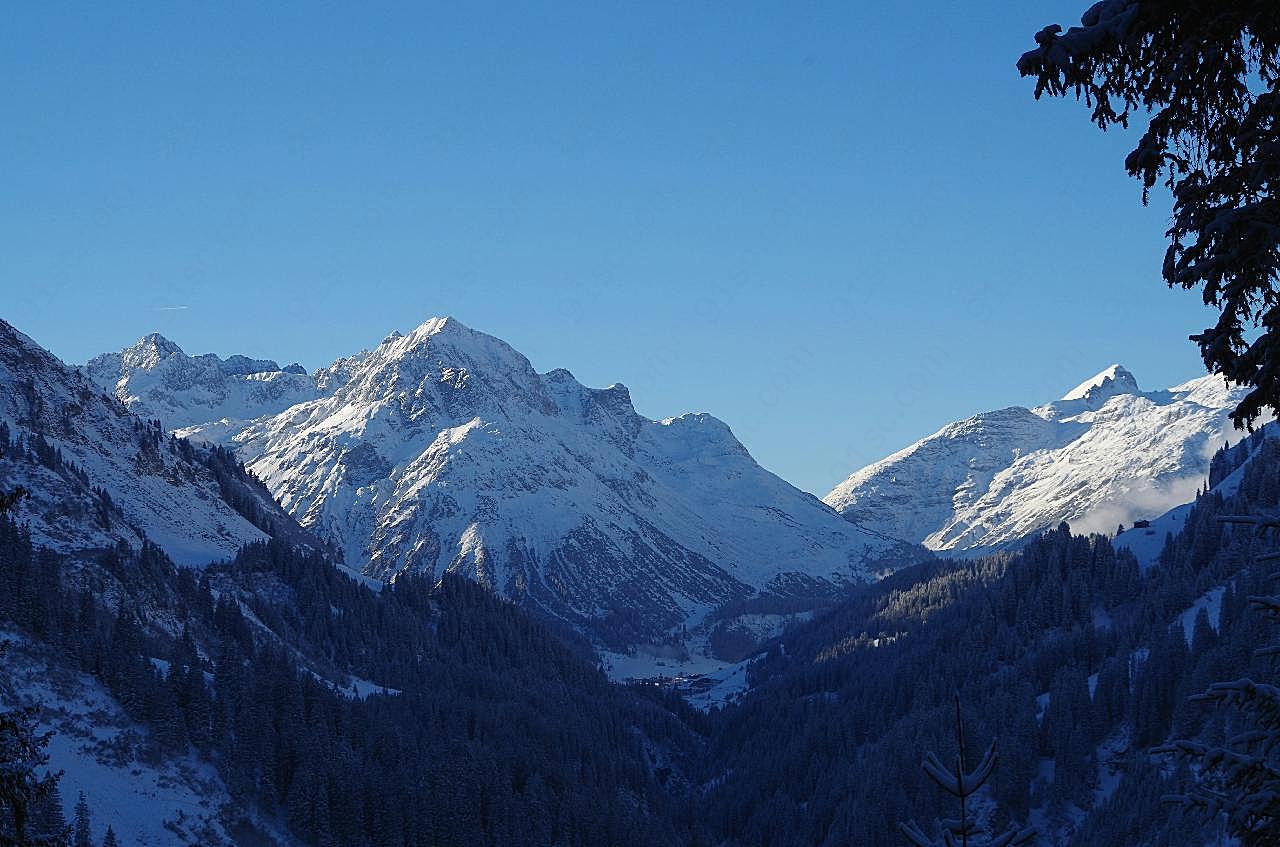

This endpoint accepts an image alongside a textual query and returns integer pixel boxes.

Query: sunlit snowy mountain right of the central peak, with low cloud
[823,365,1242,550]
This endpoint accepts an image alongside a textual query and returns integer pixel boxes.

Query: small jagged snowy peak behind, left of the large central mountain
[82,333,320,430]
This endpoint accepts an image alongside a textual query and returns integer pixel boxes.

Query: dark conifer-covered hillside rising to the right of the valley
[703,438,1280,847]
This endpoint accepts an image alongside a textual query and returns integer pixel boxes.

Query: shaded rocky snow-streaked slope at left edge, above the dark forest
[0,320,297,564]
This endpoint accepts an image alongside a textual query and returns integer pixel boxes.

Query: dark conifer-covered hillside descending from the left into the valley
[0,519,701,846]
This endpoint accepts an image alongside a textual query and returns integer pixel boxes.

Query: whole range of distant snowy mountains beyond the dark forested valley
[62,317,1239,647]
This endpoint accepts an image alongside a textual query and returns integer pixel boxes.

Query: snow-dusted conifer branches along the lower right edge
[1153,514,1280,847]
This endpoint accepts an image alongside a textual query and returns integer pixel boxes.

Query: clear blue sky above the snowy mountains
[0,0,1210,495]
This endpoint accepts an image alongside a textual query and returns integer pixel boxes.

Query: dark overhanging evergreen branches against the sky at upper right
[1018,0,1280,425]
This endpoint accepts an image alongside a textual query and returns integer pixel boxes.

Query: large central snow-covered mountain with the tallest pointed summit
[217,319,920,642]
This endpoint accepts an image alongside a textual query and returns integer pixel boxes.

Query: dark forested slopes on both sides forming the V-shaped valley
[0,427,1280,847]
